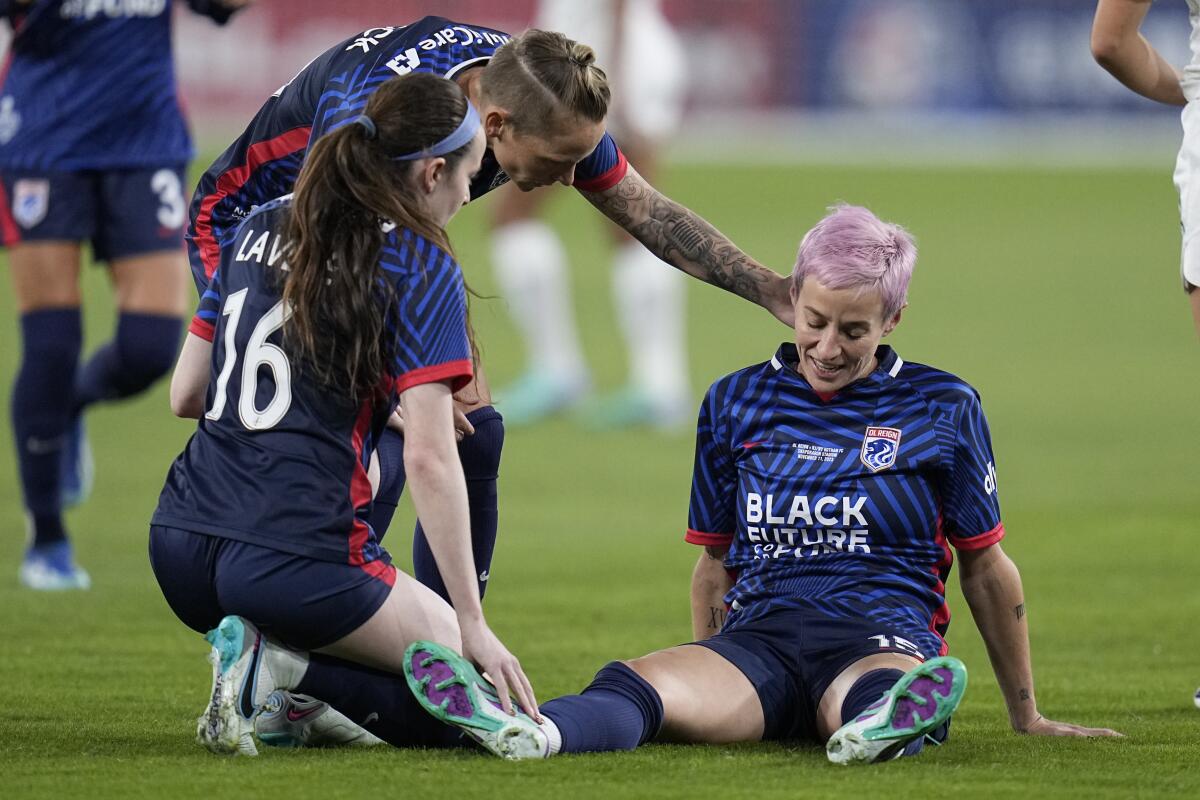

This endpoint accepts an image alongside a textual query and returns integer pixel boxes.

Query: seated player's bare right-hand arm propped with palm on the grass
[959,545,1121,736]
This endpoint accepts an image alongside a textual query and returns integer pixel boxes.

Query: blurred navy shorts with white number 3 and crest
[0,164,187,261]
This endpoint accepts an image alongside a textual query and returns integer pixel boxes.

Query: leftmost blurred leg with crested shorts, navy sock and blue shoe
[0,173,95,589]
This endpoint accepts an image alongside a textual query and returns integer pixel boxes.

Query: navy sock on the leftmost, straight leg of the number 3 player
[12,308,83,546]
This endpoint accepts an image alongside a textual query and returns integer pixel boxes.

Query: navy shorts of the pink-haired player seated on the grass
[696,607,936,741]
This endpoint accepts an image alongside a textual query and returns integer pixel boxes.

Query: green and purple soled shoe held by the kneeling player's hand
[404,642,550,760]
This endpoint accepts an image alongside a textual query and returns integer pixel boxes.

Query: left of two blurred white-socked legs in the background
[492,186,590,426]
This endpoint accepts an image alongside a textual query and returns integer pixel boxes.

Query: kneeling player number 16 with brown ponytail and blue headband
[150,74,535,754]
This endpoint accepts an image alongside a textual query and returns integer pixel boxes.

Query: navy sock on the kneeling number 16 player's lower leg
[293,652,470,747]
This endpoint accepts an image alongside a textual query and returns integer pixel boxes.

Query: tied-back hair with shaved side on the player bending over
[480,28,611,133]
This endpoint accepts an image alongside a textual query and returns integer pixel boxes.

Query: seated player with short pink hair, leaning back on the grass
[407,206,1116,764]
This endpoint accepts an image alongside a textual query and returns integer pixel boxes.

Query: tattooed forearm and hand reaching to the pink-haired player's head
[581,167,794,325]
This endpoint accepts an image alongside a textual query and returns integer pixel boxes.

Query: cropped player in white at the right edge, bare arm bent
[1092,0,1200,333]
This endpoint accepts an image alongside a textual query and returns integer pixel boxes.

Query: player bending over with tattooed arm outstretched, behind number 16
[188,17,792,705]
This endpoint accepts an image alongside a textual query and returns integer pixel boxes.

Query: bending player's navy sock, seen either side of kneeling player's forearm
[413,405,504,602]
